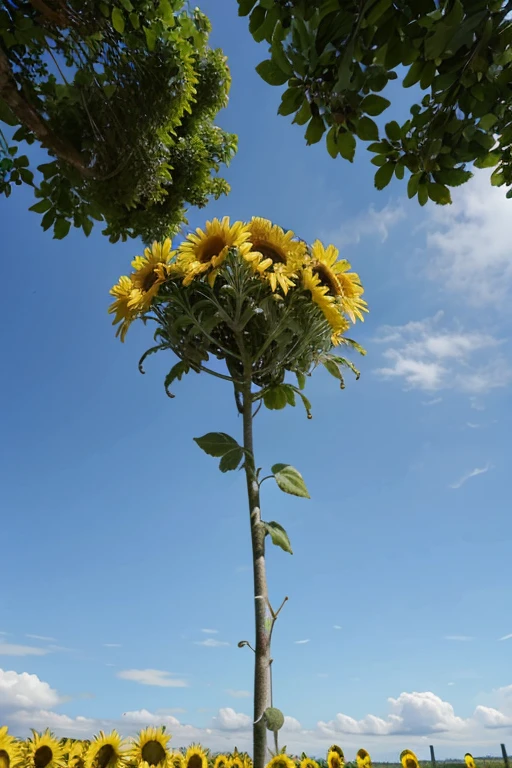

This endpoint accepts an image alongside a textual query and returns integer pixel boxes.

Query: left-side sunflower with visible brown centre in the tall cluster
[128,238,180,312]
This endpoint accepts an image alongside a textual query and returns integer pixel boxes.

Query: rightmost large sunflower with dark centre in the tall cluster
[311,240,368,323]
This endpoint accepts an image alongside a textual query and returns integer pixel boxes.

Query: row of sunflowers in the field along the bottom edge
[0,726,476,768]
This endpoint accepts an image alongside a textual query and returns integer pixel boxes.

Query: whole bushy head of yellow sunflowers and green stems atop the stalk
[109,217,367,396]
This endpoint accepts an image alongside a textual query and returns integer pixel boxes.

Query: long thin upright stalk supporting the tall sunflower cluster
[242,377,270,768]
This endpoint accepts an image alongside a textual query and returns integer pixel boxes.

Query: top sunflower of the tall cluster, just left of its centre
[177,216,251,285]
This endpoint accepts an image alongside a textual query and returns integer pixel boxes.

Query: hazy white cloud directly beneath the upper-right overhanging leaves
[426,171,512,306]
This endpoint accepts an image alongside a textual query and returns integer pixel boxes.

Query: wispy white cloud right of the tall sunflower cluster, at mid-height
[375,312,512,396]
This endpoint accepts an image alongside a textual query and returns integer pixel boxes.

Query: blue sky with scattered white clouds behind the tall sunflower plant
[0,0,512,757]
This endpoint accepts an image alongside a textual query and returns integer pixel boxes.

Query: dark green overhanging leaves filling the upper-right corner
[242,0,512,205]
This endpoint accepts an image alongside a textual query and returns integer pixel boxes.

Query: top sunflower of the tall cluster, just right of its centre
[245,216,306,295]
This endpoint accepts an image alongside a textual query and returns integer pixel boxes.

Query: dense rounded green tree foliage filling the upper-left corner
[0,0,236,242]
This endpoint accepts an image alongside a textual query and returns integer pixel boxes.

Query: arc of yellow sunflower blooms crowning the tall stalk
[109,216,368,345]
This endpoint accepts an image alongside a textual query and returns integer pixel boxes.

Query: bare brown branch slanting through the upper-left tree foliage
[0,50,96,178]
